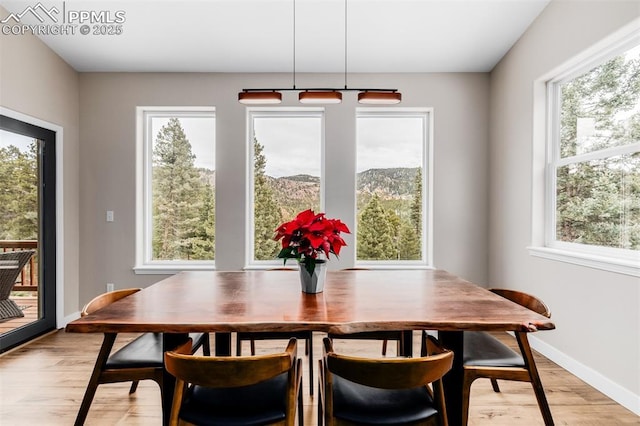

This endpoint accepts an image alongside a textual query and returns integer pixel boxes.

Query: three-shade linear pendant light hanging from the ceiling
[238,0,402,105]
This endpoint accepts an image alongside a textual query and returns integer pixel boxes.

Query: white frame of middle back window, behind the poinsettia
[244,107,325,269]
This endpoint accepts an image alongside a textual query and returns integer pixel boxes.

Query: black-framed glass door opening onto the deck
[0,115,56,352]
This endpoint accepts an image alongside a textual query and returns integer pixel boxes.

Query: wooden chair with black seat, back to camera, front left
[165,339,304,426]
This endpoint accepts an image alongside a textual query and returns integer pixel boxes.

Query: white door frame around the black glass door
[0,106,64,329]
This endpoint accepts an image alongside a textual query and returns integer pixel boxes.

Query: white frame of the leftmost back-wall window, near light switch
[133,106,216,274]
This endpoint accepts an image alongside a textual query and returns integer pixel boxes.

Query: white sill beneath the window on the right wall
[528,247,640,277]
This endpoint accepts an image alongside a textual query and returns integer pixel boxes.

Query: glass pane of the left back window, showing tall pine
[150,115,215,261]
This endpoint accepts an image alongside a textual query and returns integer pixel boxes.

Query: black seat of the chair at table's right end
[463,331,525,368]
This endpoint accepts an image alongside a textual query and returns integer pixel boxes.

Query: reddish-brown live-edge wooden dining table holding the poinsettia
[66,270,555,425]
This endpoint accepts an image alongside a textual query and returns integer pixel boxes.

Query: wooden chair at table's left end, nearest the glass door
[75,288,211,425]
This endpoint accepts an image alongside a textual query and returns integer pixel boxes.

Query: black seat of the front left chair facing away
[180,373,287,426]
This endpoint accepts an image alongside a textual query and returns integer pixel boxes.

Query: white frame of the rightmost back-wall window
[353,108,434,269]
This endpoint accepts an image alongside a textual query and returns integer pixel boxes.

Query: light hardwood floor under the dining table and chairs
[0,331,640,426]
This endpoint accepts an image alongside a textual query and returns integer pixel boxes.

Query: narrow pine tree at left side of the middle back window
[253,136,282,260]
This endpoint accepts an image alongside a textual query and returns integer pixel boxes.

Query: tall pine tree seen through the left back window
[152,117,203,260]
